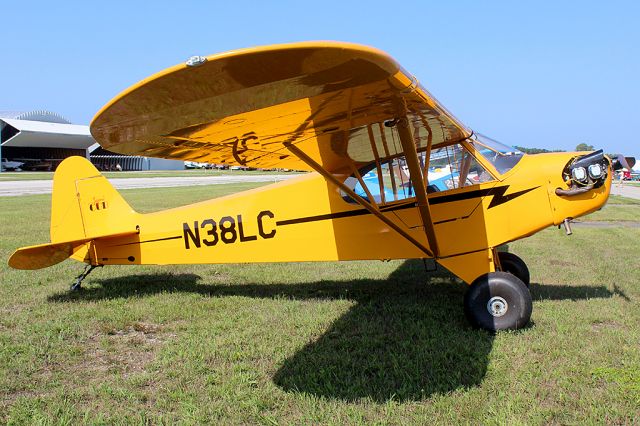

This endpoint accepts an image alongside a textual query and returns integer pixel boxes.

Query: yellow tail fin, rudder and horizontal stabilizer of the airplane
[9,157,138,269]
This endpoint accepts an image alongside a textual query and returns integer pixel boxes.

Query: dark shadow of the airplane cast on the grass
[49,260,614,402]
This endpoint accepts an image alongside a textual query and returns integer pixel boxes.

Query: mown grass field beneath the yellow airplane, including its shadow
[0,184,640,424]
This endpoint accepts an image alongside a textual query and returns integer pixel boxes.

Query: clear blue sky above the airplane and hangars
[0,0,640,157]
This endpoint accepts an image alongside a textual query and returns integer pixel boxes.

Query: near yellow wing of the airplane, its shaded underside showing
[91,42,471,172]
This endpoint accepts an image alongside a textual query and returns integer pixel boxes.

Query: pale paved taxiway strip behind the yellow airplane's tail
[0,174,300,197]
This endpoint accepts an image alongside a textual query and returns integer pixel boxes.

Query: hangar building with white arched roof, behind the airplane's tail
[0,110,184,170]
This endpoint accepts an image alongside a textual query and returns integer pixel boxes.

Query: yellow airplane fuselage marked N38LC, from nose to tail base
[79,153,611,282]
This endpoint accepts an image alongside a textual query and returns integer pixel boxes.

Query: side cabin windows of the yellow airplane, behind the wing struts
[343,144,494,204]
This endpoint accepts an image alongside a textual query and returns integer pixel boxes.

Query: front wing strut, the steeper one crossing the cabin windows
[396,101,440,258]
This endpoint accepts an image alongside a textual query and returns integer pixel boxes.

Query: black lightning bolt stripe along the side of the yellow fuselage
[276,185,540,226]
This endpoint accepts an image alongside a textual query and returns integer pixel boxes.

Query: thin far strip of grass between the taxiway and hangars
[0,169,299,182]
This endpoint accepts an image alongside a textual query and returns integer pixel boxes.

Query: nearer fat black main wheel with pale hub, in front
[464,272,533,332]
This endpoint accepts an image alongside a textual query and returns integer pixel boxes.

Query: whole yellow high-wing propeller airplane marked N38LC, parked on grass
[9,42,632,331]
